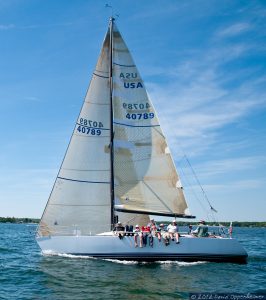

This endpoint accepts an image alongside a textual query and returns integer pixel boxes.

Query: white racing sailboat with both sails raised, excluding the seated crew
[36,17,247,262]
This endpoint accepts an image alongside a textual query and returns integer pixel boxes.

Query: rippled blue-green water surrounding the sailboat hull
[0,224,266,300]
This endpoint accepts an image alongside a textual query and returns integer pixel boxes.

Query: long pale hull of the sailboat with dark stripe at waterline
[37,235,247,263]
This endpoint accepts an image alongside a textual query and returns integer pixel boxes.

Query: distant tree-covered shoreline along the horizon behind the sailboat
[0,217,266,227]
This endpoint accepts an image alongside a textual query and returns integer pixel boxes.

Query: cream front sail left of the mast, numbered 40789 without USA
[39,26,111,235]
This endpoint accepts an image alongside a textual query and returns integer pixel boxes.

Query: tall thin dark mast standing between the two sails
[109,16,115,230]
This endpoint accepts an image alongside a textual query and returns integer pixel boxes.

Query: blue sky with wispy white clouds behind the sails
[0,0,266,221]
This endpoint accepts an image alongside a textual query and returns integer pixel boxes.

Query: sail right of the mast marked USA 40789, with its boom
[113,25,194,217]
